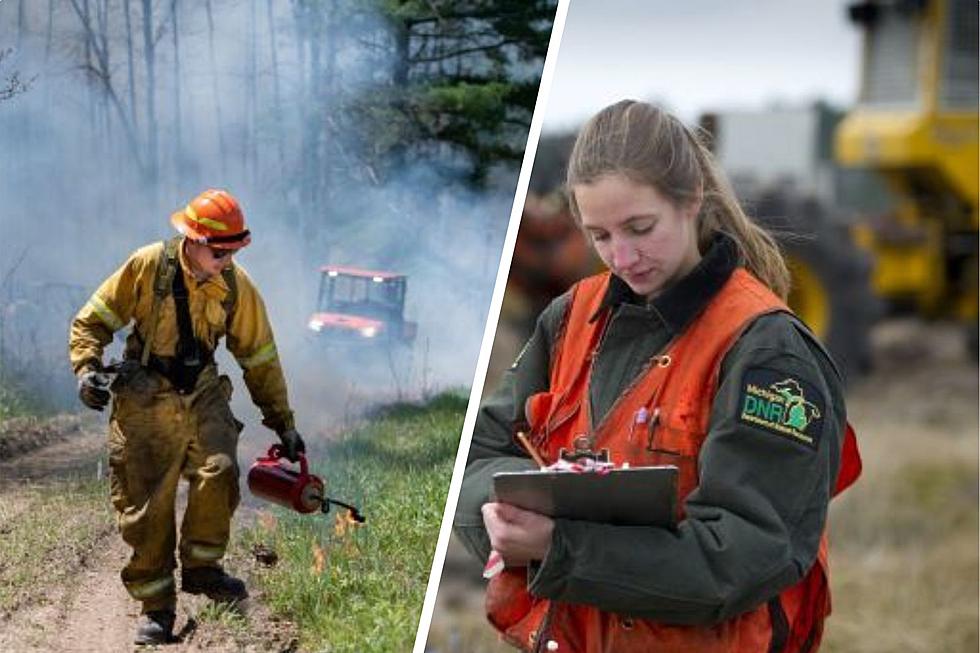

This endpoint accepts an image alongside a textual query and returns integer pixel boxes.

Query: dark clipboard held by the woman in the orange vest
[493,465,678,528]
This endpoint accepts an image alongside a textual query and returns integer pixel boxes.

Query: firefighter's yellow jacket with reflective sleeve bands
[69,243,294,433]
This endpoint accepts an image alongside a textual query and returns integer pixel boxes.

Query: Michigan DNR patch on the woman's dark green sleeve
[738,367,826,449]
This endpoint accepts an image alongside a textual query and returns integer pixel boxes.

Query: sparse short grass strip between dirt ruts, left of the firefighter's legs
[0,480,113,614]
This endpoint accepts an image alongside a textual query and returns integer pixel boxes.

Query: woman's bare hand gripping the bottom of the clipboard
[482,503,555,567]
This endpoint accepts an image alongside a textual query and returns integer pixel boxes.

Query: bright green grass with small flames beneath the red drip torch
[239,394,466,652]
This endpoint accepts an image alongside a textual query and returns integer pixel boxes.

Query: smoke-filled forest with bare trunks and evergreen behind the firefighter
[0,0,554,422]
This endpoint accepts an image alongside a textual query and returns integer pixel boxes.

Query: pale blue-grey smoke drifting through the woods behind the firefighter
[0,0,517,430]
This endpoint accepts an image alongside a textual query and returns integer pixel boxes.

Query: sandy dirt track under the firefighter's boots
[0,419,298,653]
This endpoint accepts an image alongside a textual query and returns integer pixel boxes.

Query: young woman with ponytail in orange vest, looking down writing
[456,101,860,653]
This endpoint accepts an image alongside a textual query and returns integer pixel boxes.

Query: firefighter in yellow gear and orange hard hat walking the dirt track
[69,190,304,644]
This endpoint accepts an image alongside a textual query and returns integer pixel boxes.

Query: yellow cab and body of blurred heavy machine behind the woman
[834,0,980,356]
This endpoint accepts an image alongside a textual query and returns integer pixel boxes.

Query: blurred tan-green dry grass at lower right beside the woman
[820,426,980,653]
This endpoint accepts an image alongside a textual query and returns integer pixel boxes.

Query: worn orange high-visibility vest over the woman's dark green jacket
[487,268,860,653]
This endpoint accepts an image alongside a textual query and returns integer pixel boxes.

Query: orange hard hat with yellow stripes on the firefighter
[170,188,252,249]
